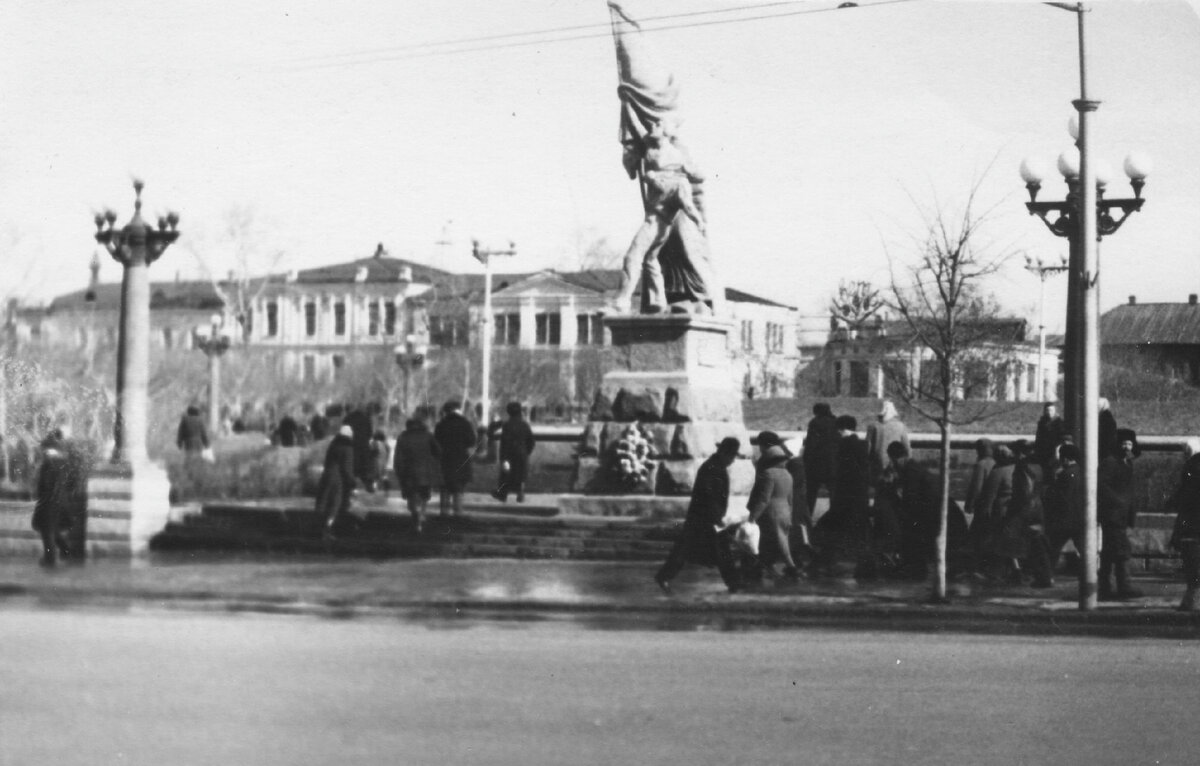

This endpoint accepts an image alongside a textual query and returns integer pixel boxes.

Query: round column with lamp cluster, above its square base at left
[95,180,179,463]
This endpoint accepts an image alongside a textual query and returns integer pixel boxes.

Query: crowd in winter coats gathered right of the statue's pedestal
[655,401,1200,610]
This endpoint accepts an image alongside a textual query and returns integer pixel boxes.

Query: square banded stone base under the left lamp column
[88,461,170,556]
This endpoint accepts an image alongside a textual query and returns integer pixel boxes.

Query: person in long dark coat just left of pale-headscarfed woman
[814,415,871,576]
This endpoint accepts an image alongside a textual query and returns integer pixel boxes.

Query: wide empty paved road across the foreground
[0,605,1200,766]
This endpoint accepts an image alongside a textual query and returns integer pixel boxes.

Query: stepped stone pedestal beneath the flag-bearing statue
[572,315,754,495]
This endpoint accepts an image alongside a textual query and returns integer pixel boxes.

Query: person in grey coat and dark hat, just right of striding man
[746,431,798,580]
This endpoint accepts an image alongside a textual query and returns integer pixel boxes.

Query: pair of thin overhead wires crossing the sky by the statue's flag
[285,0,916,68]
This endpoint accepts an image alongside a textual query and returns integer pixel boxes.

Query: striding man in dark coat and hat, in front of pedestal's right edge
[654,436,742,593]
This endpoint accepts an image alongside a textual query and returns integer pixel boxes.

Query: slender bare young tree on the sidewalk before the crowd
[878,182,1024,603]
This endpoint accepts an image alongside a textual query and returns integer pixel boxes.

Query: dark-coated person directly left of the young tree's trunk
[887,442,942,580]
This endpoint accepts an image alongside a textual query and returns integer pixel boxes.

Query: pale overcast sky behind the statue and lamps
[0,0,1200,328]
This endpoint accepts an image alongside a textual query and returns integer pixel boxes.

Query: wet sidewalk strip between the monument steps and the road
[0,552,1200,639]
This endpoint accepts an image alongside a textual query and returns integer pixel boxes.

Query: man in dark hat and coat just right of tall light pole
[1097,429,1141,600]
